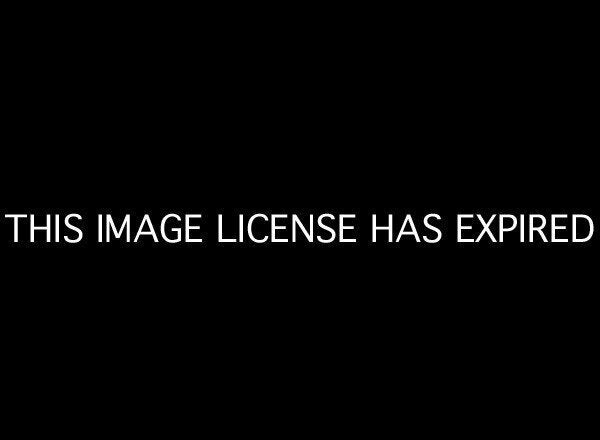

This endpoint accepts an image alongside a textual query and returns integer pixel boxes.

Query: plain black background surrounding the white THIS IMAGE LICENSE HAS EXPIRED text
[1,5,598,433]
